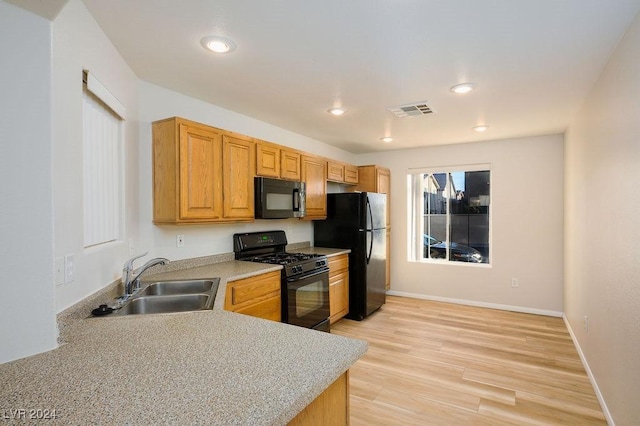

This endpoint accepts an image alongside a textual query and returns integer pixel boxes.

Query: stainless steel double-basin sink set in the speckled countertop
[115,278,220,316]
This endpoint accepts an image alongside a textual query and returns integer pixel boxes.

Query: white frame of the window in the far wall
[407,163,493,267]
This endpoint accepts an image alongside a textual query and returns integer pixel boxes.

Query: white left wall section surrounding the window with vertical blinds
[52,0,139,311]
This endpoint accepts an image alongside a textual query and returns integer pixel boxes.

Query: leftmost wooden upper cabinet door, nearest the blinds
[179,124,222,219]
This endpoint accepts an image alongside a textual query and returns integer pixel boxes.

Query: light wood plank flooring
[331,296,607,426]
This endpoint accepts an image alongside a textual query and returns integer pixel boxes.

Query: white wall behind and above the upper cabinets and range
[136,81,354,259]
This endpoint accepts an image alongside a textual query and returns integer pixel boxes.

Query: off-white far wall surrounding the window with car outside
[358,135,563,315]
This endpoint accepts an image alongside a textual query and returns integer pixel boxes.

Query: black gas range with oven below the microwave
[233,231,329,331]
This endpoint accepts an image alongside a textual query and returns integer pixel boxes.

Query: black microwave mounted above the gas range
[254,177,306,219]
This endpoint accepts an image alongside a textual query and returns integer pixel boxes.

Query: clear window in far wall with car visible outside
[409,165,491,263]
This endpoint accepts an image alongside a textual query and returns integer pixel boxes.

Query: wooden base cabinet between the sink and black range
[224,271,282,321]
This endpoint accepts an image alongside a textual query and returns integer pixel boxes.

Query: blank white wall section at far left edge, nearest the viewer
[0,1,57,363]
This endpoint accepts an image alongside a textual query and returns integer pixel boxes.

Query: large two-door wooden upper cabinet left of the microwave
[152,117,255,223]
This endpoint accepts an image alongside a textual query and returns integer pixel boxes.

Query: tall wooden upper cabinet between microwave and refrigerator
[301,154,327,220]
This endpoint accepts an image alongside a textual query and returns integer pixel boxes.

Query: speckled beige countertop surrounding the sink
[0,251,367,425]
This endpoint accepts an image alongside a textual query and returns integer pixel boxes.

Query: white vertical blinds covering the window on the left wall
[82,78,123,247]
